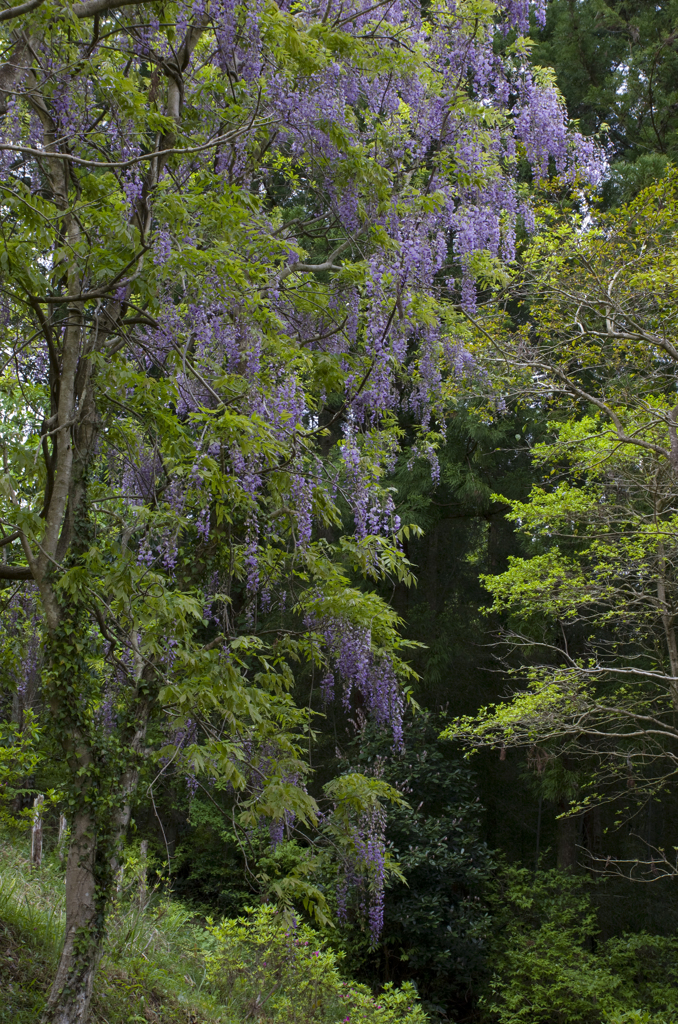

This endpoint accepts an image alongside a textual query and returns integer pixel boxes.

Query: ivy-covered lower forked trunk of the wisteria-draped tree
[42,610,157,1024]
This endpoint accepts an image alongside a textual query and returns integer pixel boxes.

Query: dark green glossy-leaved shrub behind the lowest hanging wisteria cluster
[342,712,494,1012]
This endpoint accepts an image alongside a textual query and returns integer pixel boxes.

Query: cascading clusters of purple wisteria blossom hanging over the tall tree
[0,0,603,941]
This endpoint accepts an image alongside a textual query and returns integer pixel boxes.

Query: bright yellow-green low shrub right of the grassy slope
[207,905,426,1024]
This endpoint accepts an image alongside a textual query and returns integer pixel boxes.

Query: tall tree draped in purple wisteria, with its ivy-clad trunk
[0,0,597,1024]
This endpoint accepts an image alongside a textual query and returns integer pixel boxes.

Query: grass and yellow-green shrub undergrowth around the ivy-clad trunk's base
[0,835,426,1024]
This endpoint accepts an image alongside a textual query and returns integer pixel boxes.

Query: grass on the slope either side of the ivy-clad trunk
[0,838,227,1024]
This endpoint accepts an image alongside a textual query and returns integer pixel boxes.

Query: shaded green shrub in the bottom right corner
[480,868,678,1024]
